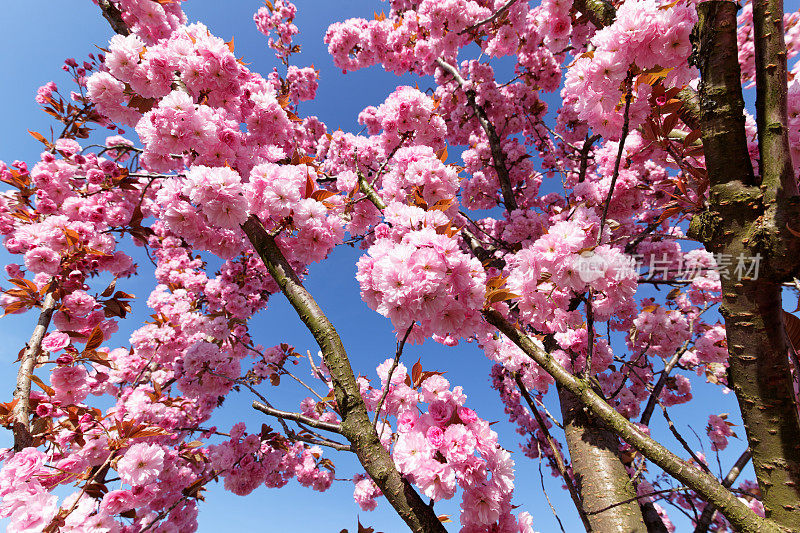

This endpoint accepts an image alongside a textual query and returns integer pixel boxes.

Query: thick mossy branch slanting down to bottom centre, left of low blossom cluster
[242,216,445,533]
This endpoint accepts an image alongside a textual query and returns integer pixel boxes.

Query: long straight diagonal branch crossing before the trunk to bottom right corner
[483,310,780,533]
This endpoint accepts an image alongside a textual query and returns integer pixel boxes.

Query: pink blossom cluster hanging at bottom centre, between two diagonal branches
[355,359,532,533]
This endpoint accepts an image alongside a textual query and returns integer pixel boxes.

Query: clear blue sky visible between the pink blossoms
[0,0,780,533]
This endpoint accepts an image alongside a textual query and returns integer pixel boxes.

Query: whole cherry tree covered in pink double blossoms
[0,0,800,533]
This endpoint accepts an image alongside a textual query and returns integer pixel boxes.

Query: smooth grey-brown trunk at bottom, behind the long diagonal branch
[558,387,647,533]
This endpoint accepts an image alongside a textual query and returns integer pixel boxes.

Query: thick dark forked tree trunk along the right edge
[690,0,800,531]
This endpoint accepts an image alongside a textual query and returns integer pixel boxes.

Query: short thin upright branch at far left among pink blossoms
[13,292,56,451]
